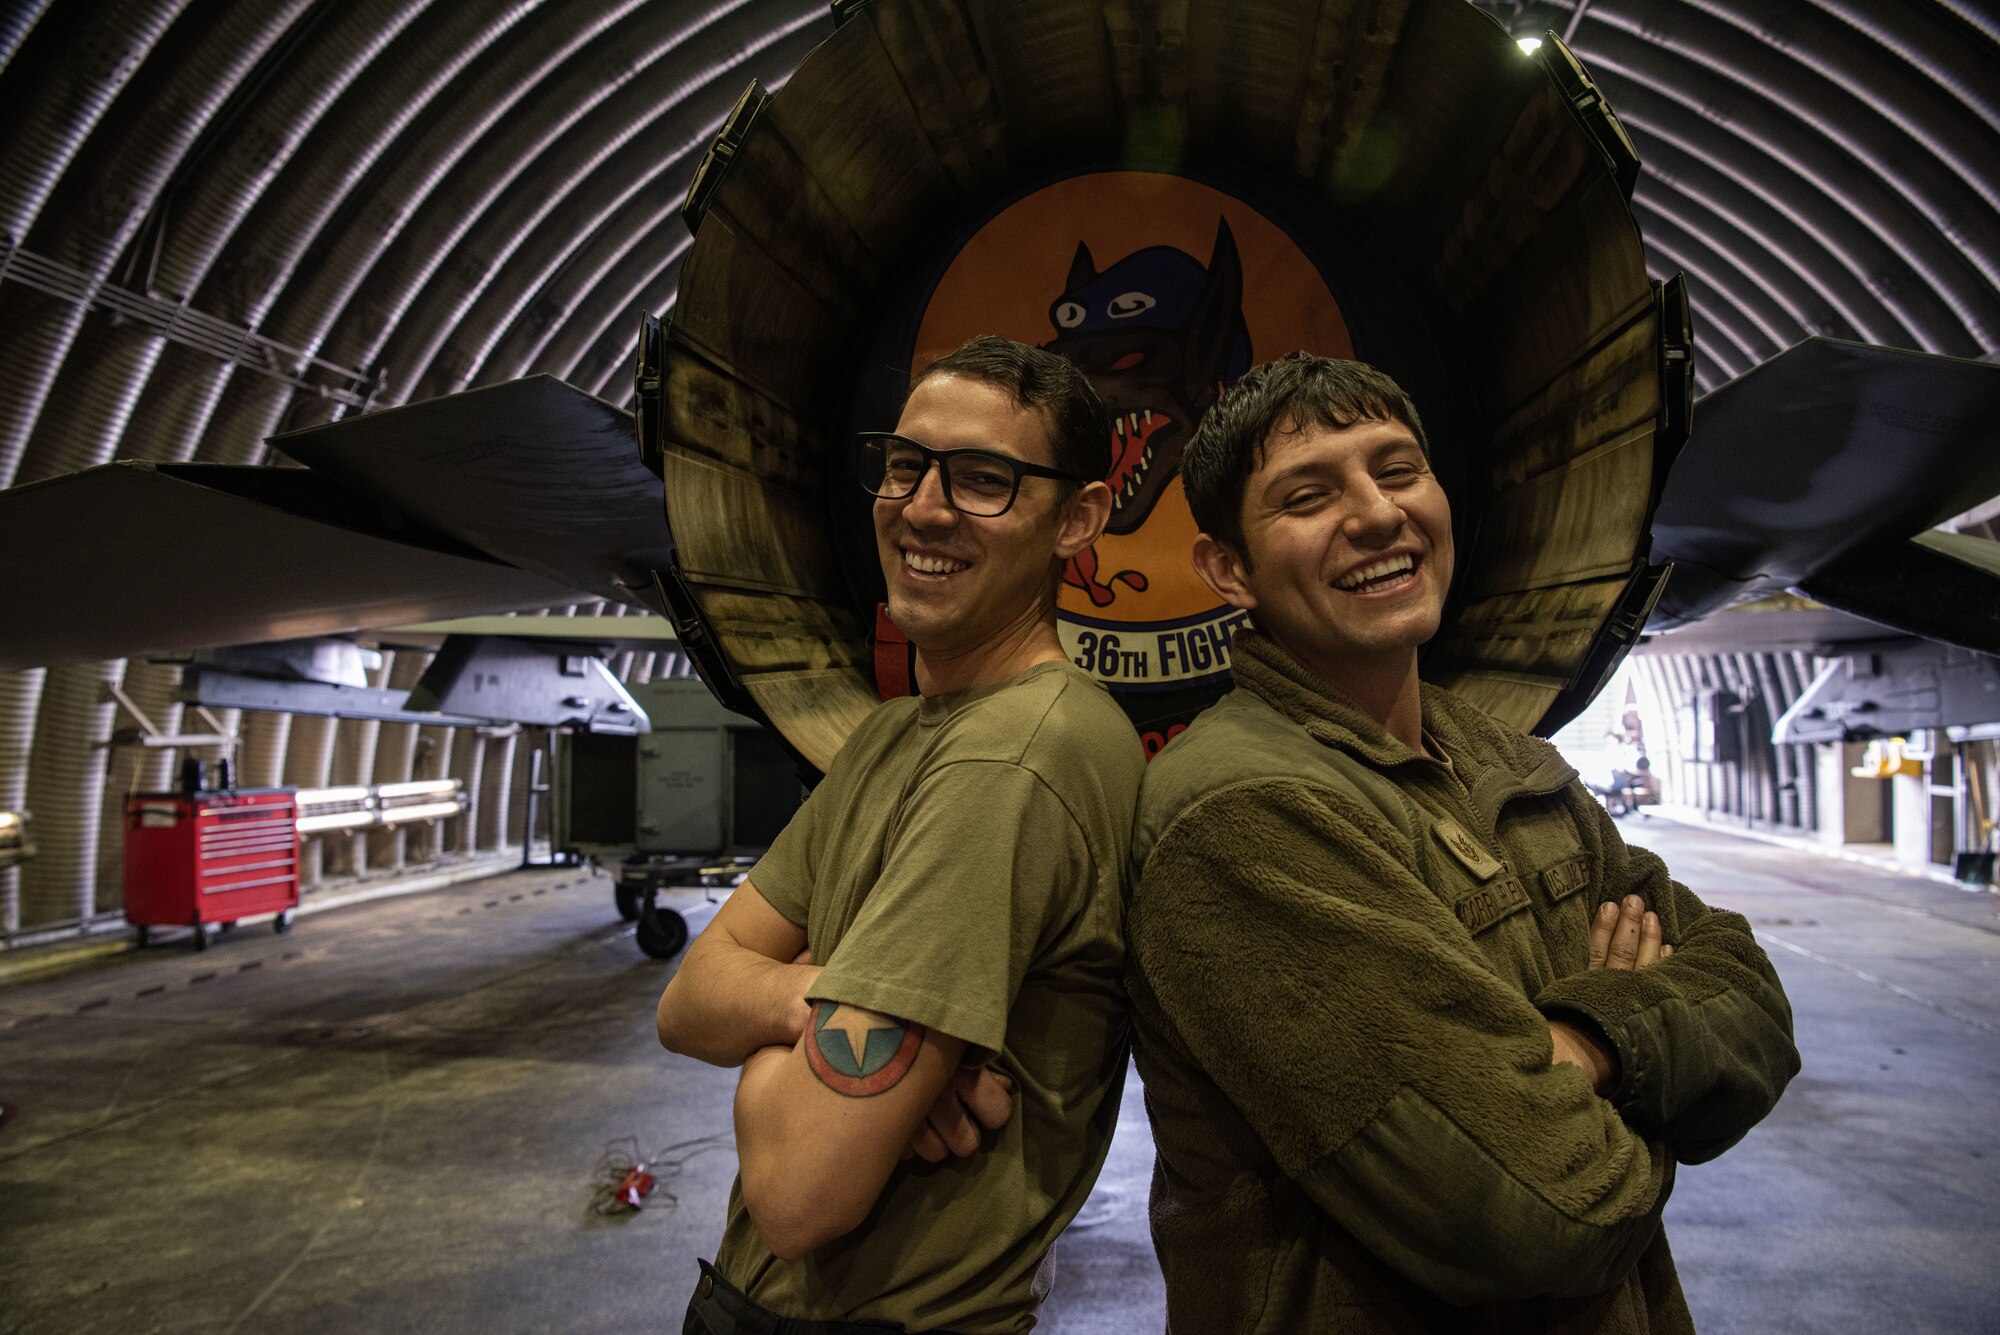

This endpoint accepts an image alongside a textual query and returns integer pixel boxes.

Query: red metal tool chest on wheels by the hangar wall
[124,787,298,947]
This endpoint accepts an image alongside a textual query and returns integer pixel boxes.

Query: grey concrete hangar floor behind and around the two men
[0,821,2000,1335]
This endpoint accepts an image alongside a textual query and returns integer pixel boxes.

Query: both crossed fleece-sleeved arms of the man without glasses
[1128,781,1796,1303]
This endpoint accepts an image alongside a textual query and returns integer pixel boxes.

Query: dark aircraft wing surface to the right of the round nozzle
[1648,338,2000,654]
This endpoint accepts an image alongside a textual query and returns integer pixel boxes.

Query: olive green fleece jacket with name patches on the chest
[1128,632,1798,1335]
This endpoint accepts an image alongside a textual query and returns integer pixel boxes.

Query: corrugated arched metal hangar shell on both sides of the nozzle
[0,0,2000,927]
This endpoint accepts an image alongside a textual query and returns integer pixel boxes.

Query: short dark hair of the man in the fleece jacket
[1180,352,1430,556]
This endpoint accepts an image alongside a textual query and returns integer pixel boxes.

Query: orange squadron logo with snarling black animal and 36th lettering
[912,172,1354,699]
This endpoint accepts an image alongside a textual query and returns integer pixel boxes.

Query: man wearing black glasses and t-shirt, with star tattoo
[658,338,1144,1335]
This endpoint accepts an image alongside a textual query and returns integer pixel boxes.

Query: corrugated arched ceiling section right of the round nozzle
[1482,0,2000,390]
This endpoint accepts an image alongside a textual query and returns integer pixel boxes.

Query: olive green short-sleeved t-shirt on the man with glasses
[716,662,1144,1335]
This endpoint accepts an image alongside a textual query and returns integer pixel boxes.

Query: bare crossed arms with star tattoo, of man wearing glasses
[656,881,1012,1259]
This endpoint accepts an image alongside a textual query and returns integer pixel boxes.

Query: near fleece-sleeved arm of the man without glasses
[1128,781,1678,1303]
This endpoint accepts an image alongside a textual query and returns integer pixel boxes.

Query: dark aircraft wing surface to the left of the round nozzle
[0,376,666,668]
